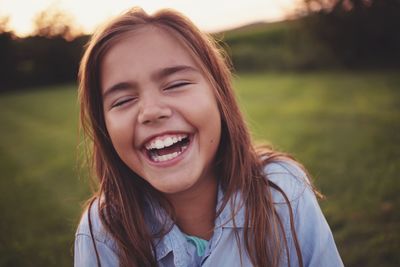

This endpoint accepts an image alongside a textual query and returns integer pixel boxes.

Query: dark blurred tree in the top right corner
[304,0,400,67]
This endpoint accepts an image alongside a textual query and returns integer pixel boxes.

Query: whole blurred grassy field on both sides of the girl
[0,72,400,266]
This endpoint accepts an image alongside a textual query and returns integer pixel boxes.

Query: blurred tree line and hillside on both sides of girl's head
[0,0,400,91]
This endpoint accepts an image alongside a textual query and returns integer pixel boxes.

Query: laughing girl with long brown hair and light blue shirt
[75,6,342,267]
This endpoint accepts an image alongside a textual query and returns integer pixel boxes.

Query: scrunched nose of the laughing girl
[138,97,172,124]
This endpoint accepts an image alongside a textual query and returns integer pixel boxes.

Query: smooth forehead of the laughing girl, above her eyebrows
[100,26,202,91]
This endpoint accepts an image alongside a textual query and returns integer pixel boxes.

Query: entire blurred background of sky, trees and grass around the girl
[0,0,400,267]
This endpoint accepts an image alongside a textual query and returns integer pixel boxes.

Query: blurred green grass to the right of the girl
[236,72,400,266]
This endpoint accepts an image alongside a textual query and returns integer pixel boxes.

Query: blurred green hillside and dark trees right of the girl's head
[222,0,400,71]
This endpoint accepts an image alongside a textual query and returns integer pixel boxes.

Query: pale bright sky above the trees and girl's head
[0,0,299,36]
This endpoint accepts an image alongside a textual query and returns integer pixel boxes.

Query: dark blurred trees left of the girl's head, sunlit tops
[0,8,89,92]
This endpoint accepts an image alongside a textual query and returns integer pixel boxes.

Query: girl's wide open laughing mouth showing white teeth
[144,134,190,162]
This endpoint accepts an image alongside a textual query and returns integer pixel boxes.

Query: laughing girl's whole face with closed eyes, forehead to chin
[100,27,221,193]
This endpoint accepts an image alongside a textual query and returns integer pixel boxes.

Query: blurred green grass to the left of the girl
[0,86,88,266]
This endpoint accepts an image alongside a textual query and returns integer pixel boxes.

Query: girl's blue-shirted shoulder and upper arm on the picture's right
[264,160,343,267]
